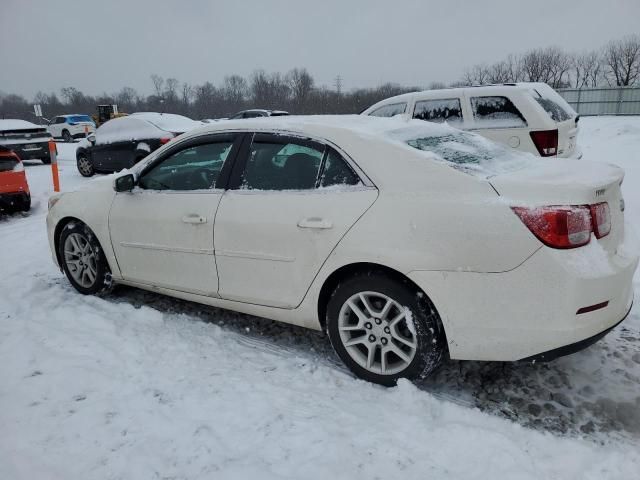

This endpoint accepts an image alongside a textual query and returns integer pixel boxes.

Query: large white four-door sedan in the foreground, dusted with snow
[47,115,638,385]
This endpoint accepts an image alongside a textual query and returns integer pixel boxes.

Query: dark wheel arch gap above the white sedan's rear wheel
[317,262,448,351]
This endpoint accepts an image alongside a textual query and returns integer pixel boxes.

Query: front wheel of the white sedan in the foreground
[58,221,112,295]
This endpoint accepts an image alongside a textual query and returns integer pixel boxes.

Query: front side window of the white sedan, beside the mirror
[139,139,233,191]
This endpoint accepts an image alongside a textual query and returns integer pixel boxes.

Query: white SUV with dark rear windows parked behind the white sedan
[362,83,582,158]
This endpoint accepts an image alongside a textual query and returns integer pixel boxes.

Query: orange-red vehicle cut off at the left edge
[0,147,31,211]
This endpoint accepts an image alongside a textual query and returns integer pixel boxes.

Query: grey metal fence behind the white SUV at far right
[557,87,640,115]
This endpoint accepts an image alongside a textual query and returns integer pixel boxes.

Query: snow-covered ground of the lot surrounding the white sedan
[0,117,640,480]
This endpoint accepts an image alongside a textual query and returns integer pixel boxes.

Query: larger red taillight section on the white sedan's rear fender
[513,206,592,248]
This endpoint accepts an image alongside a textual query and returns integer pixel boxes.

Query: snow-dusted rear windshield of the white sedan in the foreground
[392,129,535,178]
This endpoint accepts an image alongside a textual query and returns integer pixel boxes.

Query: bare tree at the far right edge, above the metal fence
[603,35,640,87]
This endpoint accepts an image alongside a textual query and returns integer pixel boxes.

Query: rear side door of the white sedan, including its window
[215,133,377,308]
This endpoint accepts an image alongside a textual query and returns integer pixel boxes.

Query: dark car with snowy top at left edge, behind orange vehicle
[0,119,51,164]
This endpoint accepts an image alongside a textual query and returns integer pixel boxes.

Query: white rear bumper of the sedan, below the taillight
[409,240,638,361]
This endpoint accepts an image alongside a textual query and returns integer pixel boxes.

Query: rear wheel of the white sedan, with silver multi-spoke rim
[326,272,446,386]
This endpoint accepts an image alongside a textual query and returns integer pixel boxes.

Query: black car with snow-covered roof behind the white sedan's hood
[76,112,202,177]
